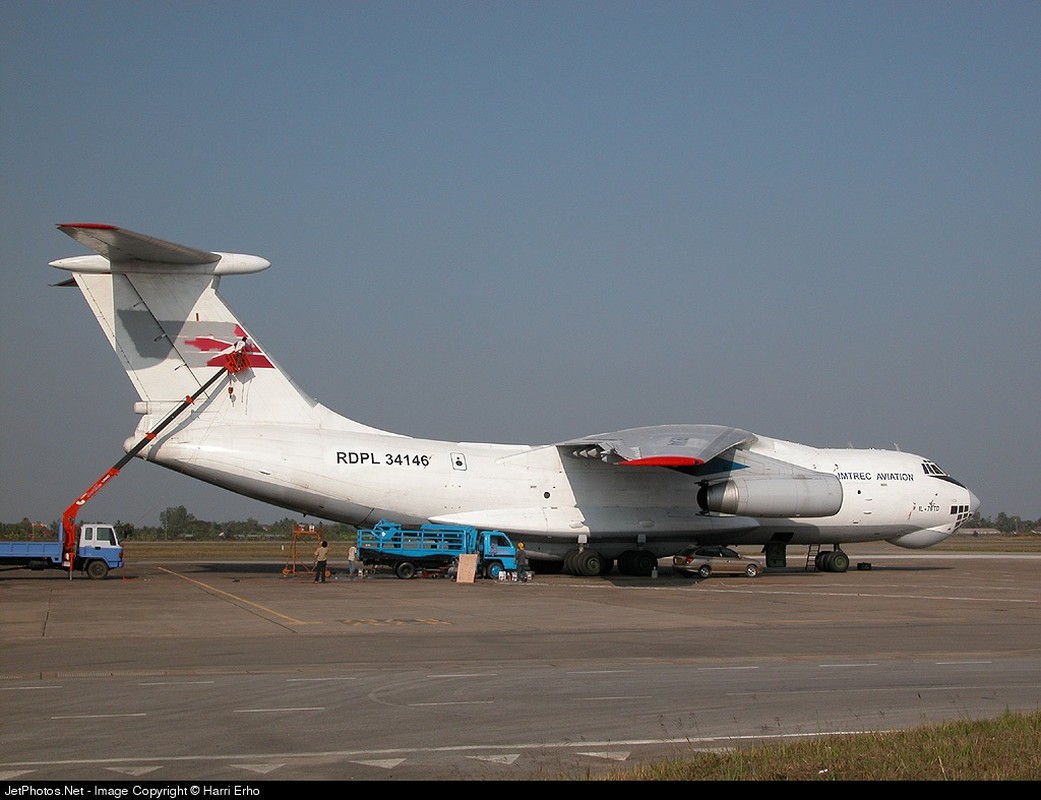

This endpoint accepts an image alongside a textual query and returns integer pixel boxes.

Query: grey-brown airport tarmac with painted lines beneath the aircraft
[0,545,1041,783]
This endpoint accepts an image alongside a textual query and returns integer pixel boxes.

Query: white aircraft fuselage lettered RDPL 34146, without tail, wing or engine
[143,419,973,558]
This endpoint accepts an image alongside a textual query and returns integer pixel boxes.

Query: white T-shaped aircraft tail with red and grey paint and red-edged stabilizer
[51,223,316,422]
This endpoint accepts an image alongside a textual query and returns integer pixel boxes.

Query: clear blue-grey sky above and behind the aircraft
[0,0,1041,525]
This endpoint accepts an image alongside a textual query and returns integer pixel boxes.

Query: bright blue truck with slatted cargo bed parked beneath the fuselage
[357,520,523,580]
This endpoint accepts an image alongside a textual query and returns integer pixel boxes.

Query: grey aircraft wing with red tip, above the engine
[556,425,756,467]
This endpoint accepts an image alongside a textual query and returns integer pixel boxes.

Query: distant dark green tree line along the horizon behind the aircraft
[0,505,1041,542]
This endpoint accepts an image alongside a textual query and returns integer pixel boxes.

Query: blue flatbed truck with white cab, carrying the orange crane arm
[0,522,123,580]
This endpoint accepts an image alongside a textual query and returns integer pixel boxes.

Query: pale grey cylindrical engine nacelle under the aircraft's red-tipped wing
[697,473,842,517]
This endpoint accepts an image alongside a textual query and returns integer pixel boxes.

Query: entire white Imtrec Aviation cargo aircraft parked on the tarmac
[51,223,979,575]
